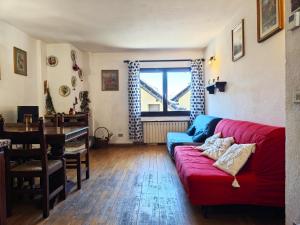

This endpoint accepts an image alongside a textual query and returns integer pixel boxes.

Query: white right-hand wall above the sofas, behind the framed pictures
[205,0,285,126]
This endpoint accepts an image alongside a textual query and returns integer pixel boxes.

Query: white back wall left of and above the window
[88,50,203,143]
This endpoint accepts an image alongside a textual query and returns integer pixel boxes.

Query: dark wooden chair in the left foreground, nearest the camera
[0,118,66,218]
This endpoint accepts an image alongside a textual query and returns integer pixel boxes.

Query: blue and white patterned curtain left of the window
[128,61,143,143]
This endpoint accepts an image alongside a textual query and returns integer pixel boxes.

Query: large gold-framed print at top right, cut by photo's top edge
[257,0,283,42]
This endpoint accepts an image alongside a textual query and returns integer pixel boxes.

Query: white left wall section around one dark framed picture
[0,21,45,122]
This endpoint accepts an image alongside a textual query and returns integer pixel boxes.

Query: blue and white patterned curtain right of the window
[190,59,205,123]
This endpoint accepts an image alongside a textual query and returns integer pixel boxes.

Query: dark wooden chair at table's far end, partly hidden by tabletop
[46,114,90,189]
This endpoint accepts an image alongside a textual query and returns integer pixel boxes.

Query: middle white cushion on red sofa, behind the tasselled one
[202,137,234,160]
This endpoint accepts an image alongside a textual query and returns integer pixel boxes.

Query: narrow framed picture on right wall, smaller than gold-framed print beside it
[231,19,245,62]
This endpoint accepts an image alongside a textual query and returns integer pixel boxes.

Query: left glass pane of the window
[140,72,163,112]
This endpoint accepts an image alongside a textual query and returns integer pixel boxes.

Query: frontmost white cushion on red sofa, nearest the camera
[213,144,255,176]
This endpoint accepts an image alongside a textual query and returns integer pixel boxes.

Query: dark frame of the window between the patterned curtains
[140,67,191,117]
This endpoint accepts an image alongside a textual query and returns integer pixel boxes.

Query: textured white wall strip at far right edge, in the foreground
[286,1,300,225]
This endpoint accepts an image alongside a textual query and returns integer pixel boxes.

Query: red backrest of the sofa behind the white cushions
[215,119,285,179]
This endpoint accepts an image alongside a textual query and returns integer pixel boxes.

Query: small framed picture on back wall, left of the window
[101,70,119,91]
